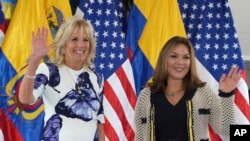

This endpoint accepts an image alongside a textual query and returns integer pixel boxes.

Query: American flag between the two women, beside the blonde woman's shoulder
[76,0,136,141]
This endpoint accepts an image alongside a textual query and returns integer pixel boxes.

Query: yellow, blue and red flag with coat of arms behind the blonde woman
[0,0,72,141]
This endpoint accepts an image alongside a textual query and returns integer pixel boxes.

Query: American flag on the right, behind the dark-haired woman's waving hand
[178,0,250,139]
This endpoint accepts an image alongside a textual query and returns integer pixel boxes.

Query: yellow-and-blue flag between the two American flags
[126,0,186,95]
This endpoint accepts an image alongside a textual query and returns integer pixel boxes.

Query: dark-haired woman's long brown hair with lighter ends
[147,36,205,94]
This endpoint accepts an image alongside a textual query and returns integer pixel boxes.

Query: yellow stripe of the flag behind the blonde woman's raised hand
[2,0,72,72]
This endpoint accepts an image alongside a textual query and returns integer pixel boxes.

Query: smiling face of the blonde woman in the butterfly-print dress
[64,28,90,70]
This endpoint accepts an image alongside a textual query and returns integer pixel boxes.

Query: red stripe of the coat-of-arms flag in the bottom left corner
[0,108,24,141]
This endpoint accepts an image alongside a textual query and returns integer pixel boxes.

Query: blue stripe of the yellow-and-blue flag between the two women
[126,5,153,95]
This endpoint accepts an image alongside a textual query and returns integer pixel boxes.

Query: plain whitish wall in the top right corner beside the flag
[228,0,250,61]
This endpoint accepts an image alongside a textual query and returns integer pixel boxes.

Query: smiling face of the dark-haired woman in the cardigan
[167,44,191,80]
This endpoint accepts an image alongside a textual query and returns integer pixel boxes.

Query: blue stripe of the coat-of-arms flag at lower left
[0,49,44,141]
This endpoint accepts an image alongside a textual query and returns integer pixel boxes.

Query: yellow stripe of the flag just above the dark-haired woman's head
[135,0,186,67]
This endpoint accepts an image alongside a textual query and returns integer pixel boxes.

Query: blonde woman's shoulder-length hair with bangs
[52,16,96,67]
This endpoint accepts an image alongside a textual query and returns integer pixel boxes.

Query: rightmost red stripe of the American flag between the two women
[116,67,136,109]
